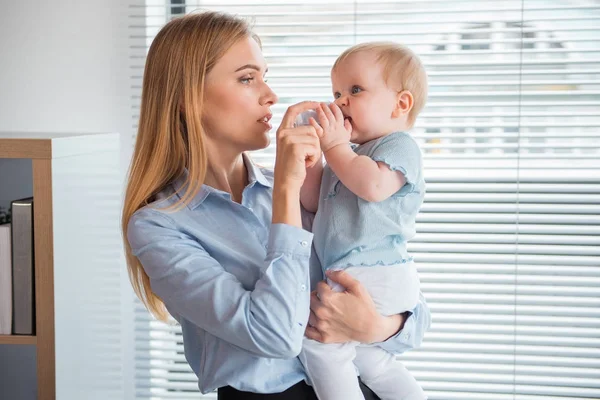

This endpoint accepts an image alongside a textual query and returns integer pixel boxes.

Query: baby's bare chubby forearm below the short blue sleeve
[325,146,406,201]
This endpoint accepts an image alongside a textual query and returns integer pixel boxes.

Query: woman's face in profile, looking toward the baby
[202,37,277,152]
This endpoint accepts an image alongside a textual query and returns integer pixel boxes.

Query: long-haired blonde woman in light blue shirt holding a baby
[122,12,429,400]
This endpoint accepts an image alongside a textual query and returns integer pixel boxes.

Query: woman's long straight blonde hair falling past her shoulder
[121,12,260,321]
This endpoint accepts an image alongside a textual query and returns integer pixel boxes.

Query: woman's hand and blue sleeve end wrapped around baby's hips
[306,271,431,353]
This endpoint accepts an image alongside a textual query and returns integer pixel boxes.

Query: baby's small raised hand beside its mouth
[311,103,352,152]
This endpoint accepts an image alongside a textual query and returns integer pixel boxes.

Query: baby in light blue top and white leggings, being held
[300,42,427,400]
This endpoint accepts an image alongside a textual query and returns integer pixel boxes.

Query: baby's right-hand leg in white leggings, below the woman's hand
[354,346,427,400]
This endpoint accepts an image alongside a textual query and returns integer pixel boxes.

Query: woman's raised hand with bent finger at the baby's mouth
[274,101,321,190]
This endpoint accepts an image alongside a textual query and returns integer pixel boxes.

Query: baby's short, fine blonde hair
[331,42,428,127]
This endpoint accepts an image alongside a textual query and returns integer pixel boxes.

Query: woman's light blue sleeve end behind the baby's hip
[377,293,431,354]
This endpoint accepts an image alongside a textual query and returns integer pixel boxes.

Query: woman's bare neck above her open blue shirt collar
[204,154,248,203]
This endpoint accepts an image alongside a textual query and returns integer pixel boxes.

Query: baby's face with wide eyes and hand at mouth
[331,52,398,144]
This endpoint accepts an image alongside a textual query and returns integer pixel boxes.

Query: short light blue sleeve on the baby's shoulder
[371,132,422,185]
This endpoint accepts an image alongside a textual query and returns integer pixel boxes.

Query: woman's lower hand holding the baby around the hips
[306,271,406,343]
